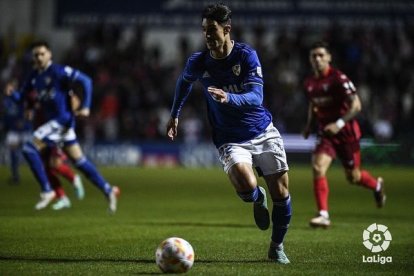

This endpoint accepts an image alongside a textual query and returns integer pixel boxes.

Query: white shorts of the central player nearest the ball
[219,123,289,176]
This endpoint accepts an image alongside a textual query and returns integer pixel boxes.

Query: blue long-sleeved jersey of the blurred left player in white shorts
[15,63,92,127]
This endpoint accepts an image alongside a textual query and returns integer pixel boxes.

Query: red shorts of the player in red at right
[314,136,361,169]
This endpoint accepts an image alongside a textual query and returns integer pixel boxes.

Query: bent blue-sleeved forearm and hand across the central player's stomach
[207,84,263,106]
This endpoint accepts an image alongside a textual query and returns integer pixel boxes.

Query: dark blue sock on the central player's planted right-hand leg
[272,195,292,244]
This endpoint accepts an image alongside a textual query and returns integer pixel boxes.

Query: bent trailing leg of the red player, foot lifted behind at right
[337,142,386,208]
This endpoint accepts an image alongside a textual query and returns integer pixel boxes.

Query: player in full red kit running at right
[303,42,386,228]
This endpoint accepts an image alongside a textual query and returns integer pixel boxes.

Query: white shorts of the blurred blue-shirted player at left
[33,120,76,144]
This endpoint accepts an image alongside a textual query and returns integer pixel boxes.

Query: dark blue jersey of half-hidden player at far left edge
[2,96,31,131]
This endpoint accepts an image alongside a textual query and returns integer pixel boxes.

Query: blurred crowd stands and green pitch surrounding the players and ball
[0,0,414,276]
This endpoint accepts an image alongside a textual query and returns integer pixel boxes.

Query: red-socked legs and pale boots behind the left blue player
[42,146,85,210]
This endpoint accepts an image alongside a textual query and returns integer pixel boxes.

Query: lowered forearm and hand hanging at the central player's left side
[167,75,192,140]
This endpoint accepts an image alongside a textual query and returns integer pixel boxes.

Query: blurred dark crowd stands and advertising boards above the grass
[0,0,414,166]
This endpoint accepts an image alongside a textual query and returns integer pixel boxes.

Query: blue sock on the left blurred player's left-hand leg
[23,142,52,192]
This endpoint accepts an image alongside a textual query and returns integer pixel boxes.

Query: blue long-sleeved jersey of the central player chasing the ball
[171,43,272,148]
